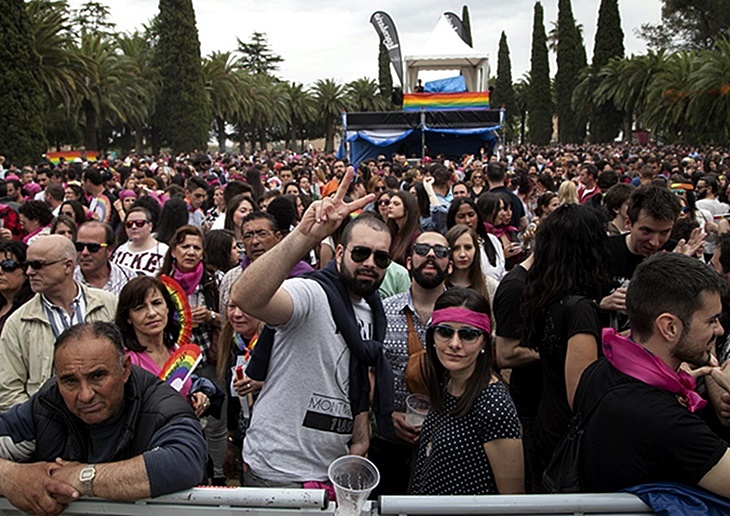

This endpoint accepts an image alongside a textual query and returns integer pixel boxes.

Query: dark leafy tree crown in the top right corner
[638,0,730,50]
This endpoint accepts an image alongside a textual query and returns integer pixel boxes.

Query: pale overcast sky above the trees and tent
[69,0,661,85]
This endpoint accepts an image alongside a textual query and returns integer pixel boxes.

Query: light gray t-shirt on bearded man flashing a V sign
[243,278,367,483]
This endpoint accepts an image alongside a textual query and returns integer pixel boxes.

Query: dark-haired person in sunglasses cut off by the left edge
[0,241,33,333]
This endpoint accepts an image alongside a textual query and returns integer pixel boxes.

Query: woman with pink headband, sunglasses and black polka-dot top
[410,287,524,495]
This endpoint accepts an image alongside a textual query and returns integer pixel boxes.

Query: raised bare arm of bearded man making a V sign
[231,171,374,325]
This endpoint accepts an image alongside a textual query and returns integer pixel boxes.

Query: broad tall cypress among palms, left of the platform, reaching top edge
[155,0,212,152]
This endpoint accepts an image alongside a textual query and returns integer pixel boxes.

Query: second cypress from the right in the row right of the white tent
[555,0,586,143]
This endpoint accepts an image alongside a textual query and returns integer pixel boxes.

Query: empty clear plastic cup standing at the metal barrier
[327,455,380,516]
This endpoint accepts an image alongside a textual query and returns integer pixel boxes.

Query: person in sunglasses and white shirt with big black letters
[112,206,168,276]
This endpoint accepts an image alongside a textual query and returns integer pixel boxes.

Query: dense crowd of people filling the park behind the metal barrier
[0,144,730,513]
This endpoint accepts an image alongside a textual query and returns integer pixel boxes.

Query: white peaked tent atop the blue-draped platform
[404,15,489,93]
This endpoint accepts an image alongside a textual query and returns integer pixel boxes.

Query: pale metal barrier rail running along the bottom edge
[0,487,654,516]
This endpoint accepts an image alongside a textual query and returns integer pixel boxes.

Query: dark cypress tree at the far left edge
[0,0,47,165]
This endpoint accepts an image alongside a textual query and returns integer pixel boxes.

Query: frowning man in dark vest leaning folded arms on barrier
[0,322,207,514]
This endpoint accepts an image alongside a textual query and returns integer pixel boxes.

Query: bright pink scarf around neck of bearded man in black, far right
[603,328,707,412]
